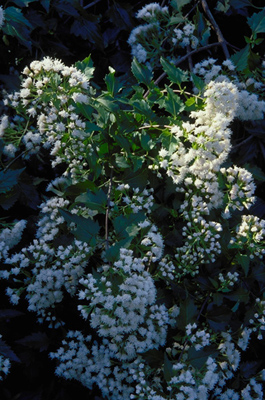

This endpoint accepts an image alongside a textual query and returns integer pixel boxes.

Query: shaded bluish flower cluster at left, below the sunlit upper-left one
[1,198,91,326]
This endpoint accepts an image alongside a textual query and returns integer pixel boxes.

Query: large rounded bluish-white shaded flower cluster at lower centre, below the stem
[79,249,168,360]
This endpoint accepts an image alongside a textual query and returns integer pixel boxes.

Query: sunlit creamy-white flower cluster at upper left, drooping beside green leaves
[1,57,91,182]
